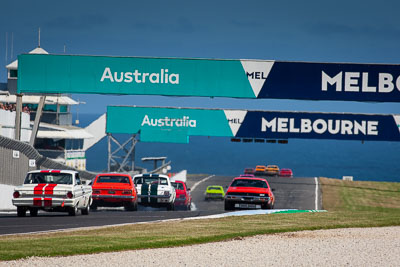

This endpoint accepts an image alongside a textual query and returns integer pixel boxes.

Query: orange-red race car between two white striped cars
[90,173,138,211]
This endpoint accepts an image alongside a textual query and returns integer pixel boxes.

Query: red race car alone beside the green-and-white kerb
[225,177,275,210]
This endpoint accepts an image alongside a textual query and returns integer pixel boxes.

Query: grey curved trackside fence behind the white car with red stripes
[0,136,96,185]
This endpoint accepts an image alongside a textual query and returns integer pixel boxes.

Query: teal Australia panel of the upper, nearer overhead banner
[18,54,255,98]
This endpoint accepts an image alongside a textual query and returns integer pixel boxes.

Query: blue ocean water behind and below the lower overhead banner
[79,114,400,182]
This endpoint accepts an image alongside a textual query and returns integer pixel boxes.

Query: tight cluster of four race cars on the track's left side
[12,170,192,217]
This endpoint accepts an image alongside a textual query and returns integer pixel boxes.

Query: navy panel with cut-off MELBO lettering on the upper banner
[257,62,400,102]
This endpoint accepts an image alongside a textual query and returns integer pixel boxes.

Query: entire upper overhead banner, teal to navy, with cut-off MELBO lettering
[18,54,400,102]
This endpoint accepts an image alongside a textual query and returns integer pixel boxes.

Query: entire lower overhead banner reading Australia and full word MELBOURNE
[107,106,400,143]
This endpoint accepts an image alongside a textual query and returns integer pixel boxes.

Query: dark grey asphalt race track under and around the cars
[0,175,321,235]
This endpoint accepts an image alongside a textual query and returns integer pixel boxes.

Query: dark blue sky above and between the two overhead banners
[0,0,400,113]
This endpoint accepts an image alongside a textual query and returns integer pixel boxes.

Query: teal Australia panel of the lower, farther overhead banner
[106,106,232,143]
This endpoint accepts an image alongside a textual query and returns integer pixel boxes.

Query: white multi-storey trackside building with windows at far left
[0,47,105,170]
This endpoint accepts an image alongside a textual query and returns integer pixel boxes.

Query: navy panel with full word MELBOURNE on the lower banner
[236,111,400,141]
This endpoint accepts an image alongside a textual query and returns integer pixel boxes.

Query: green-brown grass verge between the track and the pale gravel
[0,178,400,260]
